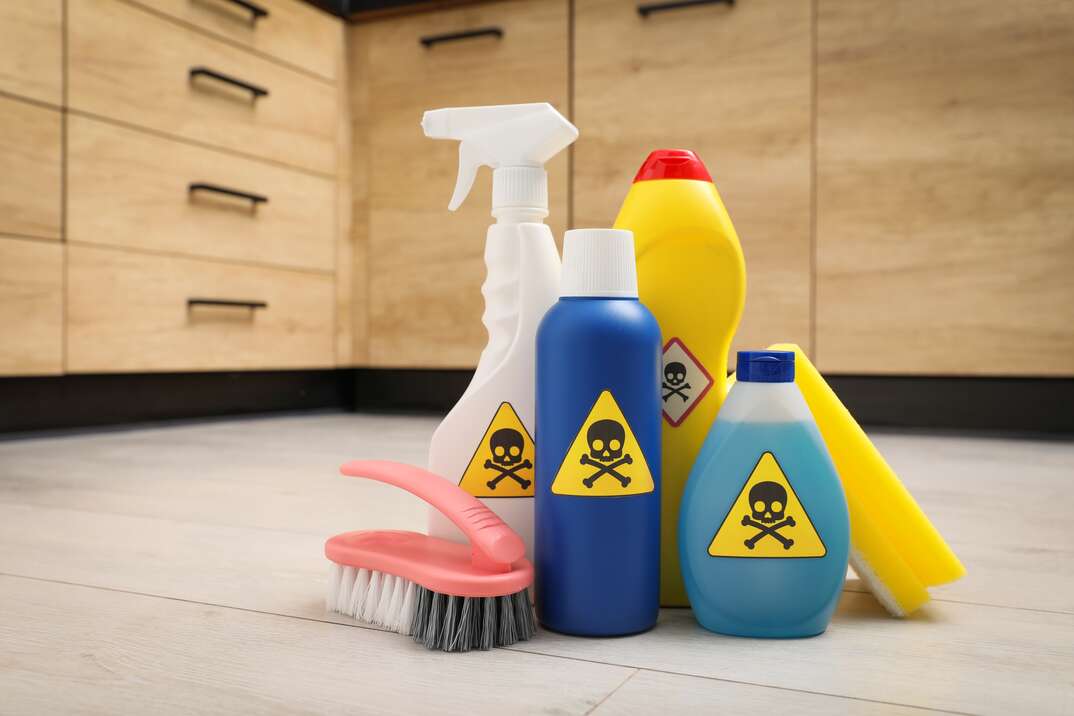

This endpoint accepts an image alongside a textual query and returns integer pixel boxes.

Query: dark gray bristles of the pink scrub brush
[410,586,537,652]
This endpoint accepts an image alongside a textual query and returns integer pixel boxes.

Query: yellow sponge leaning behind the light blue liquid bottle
[770,344,966,616]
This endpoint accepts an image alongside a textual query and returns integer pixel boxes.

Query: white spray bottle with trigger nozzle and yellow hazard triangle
[421,102,578,555]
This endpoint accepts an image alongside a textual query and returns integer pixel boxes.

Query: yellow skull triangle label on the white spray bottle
[459,403,534,497]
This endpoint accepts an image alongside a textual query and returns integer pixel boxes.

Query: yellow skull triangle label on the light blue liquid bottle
[709,452,828,557]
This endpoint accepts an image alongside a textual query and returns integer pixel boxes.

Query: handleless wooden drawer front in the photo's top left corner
[0,0,63,105]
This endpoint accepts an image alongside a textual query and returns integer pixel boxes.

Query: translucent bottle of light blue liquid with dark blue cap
[679,351,850,638]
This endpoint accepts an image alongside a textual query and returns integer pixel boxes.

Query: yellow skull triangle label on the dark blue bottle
[552,391,655,497]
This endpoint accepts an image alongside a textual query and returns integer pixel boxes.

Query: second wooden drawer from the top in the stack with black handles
[68,0,338,176]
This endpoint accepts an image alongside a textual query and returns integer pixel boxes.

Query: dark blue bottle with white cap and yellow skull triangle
[535,229,661,637]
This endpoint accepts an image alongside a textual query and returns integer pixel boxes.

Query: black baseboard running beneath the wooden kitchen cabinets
[0,368,1074,435]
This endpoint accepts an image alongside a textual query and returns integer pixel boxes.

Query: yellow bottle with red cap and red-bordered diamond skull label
[615,149,745,607]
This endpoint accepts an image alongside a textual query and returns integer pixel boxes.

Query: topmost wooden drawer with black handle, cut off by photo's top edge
[136,0,343,79]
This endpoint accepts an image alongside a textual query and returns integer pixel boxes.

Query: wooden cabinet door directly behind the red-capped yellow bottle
[574,0,812,358]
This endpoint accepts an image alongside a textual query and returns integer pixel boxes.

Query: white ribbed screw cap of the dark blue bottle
[560,229,638,298]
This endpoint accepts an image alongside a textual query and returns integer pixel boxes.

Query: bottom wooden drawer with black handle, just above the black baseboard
[67,244,334,372]
